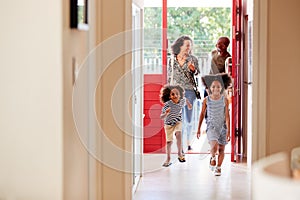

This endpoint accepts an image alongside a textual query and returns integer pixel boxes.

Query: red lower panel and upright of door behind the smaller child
[144,0,168,153]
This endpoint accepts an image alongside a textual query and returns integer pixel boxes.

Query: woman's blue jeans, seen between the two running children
[182,90,196,145]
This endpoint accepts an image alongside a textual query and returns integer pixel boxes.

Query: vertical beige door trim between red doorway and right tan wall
[248,0,268,163]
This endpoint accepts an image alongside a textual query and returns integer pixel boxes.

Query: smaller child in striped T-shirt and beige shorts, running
[160,85,192,167]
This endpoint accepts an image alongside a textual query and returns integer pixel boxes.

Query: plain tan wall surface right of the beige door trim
[266,0,300,154]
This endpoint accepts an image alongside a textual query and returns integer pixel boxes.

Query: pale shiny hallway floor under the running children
[133,135,251,200]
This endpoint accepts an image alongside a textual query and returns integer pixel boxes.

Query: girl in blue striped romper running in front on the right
[197,73,231,176]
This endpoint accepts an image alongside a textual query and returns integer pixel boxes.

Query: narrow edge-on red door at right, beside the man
[231,0,242,162]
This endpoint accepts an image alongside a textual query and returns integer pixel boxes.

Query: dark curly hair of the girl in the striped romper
[201,73,231,93]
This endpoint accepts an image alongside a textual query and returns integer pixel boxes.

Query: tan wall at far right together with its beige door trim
[251,0,300,161]
